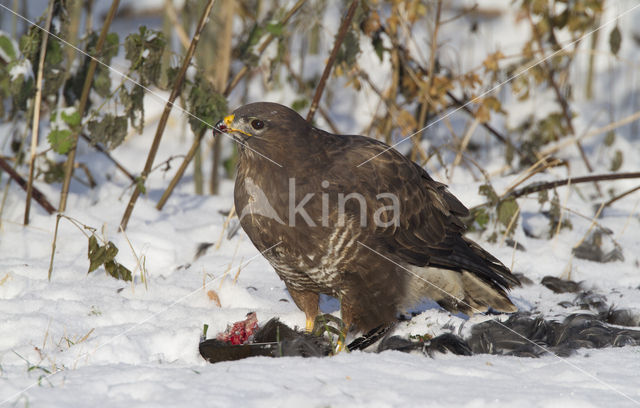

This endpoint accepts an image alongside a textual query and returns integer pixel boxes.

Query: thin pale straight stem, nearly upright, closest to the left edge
[24,0,54,225]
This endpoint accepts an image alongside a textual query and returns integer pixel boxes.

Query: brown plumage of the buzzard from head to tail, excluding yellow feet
[218,103,519,330]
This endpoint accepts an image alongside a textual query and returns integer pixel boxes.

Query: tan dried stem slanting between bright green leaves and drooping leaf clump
[58,0,120,212]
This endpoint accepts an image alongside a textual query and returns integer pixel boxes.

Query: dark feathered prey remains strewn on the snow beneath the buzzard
[199,300,640,363]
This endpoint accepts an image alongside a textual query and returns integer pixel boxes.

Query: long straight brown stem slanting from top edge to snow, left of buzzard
[120,0,215,231]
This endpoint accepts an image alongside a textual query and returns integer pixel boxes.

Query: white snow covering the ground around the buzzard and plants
[0,1,640,407]
